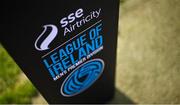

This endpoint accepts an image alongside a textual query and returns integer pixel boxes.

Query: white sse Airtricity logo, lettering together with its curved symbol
[35,8,101,51]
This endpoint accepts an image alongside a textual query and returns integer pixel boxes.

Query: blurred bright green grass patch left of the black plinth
[0,45,37,104]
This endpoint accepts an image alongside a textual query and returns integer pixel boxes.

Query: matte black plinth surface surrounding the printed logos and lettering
[0,0,119,103]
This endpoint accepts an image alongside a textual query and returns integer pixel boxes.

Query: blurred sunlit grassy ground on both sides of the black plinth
[0,0,180,104]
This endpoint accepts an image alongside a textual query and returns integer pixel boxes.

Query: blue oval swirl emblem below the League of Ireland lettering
[61,59,104,97]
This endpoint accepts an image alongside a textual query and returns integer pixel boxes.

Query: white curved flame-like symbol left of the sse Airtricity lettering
[35,25,58,51]
